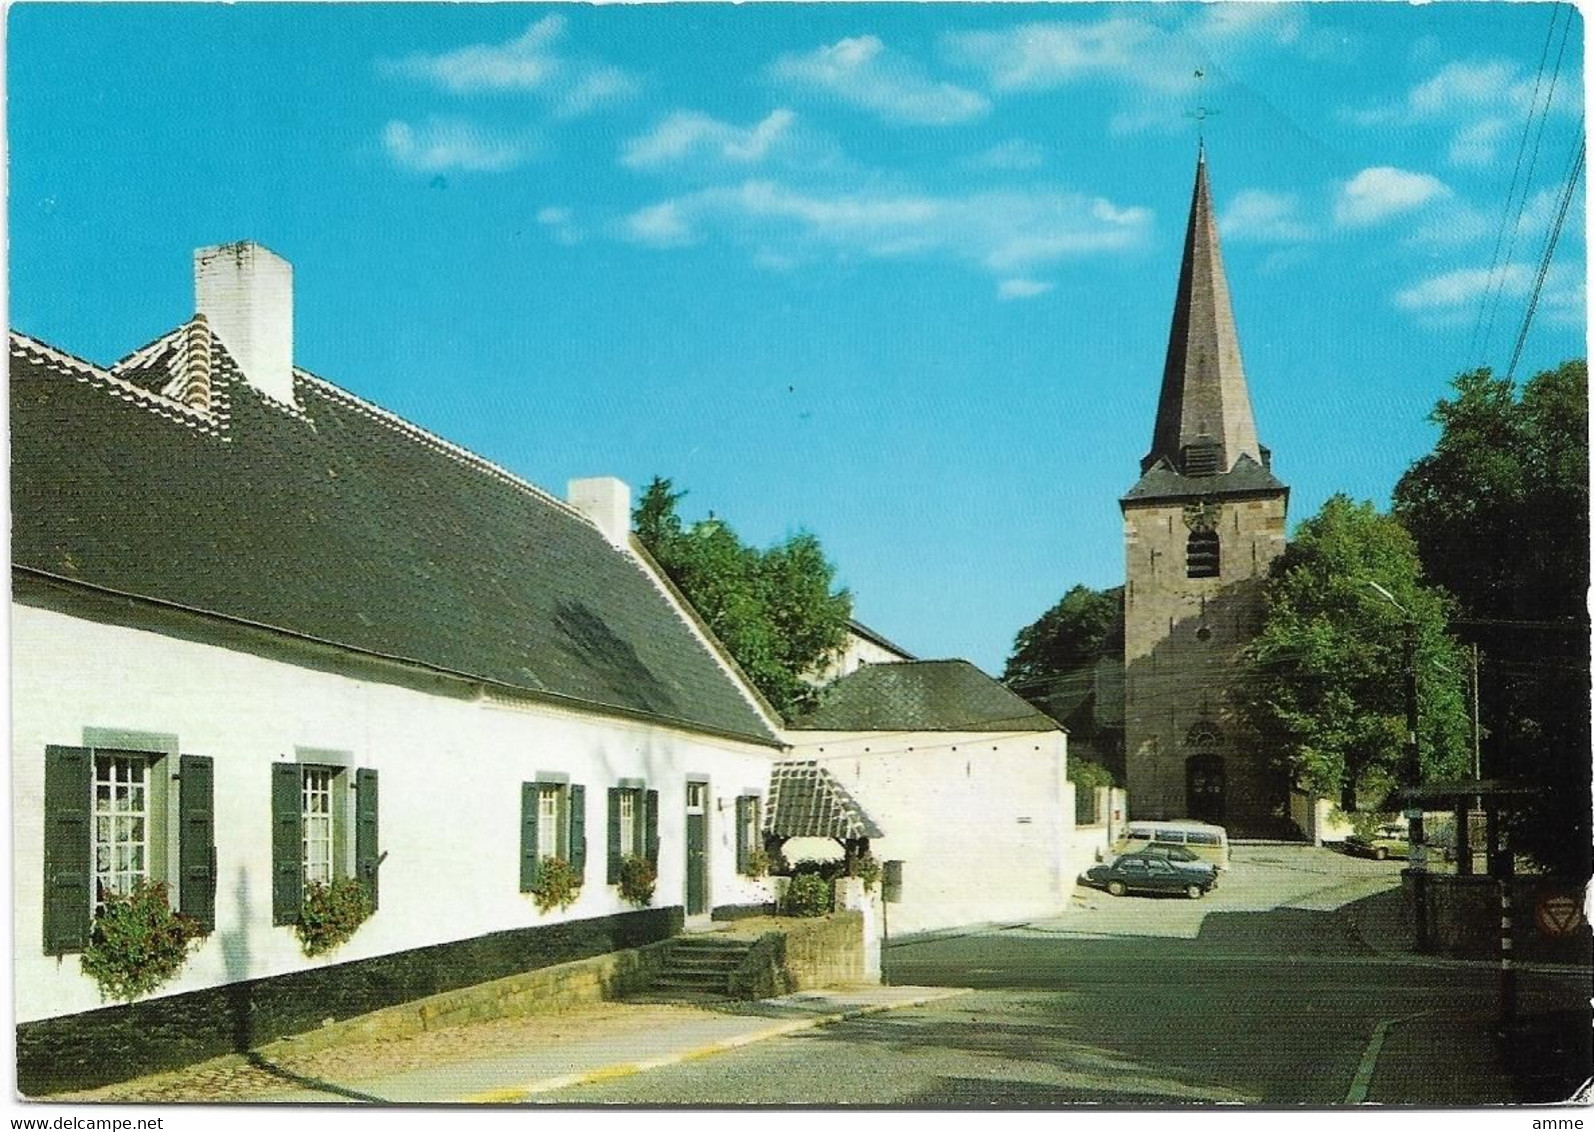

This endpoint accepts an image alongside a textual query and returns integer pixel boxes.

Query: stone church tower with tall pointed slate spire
[1119,148,1290,834]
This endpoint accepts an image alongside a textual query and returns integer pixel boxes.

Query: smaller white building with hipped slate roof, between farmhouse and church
[781,660,1079,934]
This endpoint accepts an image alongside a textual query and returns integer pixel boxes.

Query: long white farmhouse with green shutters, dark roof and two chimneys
[10,244,783,1092]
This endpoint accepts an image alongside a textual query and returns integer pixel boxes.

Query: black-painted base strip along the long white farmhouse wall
[16,906,682,1097]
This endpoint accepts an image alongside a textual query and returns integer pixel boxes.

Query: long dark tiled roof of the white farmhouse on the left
[11,330,778,746]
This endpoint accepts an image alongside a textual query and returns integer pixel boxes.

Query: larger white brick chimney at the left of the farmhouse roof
[194,241,295,405]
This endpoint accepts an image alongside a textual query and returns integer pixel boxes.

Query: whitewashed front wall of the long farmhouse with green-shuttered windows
[11,604,776,1022]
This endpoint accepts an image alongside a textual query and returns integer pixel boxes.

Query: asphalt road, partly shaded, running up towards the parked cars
[544,847,1586,1108]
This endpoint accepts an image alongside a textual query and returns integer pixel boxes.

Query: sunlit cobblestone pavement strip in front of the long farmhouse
[48,1003,730,1103]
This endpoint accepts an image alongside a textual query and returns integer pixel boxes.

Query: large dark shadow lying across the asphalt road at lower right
[879,891,1594,1106]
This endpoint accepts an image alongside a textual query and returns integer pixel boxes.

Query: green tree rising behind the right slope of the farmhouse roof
[631,477,853,719]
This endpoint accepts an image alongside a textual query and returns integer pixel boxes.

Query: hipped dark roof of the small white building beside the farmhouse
[792,660,1060,732]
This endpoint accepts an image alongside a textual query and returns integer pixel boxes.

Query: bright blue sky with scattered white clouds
[6,3,1586,673]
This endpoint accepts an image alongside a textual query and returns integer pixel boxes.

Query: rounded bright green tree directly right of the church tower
[1242,496,1470,805]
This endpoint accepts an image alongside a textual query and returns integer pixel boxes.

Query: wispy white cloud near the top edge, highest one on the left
[379,14,639,115]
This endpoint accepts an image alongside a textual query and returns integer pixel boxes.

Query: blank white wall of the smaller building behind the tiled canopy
[786,732,1074,936]
